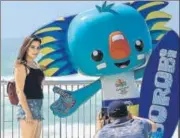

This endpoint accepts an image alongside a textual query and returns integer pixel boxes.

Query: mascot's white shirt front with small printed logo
[101,72,140,100]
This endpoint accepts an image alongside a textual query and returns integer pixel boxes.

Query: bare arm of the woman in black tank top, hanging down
[15,64,31,114]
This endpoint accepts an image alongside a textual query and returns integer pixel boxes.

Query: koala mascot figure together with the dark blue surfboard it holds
[33,1,179,138]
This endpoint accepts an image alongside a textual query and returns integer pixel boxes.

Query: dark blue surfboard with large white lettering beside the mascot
[140,31,179,138]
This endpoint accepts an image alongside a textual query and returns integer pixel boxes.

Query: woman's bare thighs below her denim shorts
[20,120,38,138]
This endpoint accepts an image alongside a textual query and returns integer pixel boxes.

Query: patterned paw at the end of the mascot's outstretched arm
[50,87,76,117]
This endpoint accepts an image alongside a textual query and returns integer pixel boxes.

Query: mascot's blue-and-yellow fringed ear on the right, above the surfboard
[125,1,171,48]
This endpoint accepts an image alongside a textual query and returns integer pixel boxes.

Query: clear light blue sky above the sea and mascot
[1,1,179,39]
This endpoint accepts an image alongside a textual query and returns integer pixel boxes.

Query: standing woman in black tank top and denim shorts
[15,36,44,138]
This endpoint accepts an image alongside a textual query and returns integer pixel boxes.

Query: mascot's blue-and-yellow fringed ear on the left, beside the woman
[32,15,77,77]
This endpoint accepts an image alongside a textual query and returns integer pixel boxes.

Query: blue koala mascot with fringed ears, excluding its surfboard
[33,1,179,138]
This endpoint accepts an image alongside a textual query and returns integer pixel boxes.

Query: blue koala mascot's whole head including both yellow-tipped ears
[33,1,171,76]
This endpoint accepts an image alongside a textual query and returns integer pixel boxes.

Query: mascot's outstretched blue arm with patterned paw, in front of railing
[50,80,101,117]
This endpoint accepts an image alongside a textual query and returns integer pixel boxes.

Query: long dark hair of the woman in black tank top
[16,35,41,65]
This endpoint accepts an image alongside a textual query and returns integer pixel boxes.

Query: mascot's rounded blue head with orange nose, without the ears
[68,1,152,76]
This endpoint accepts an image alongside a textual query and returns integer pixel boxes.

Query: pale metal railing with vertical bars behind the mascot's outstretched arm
[0,81,140,138]
